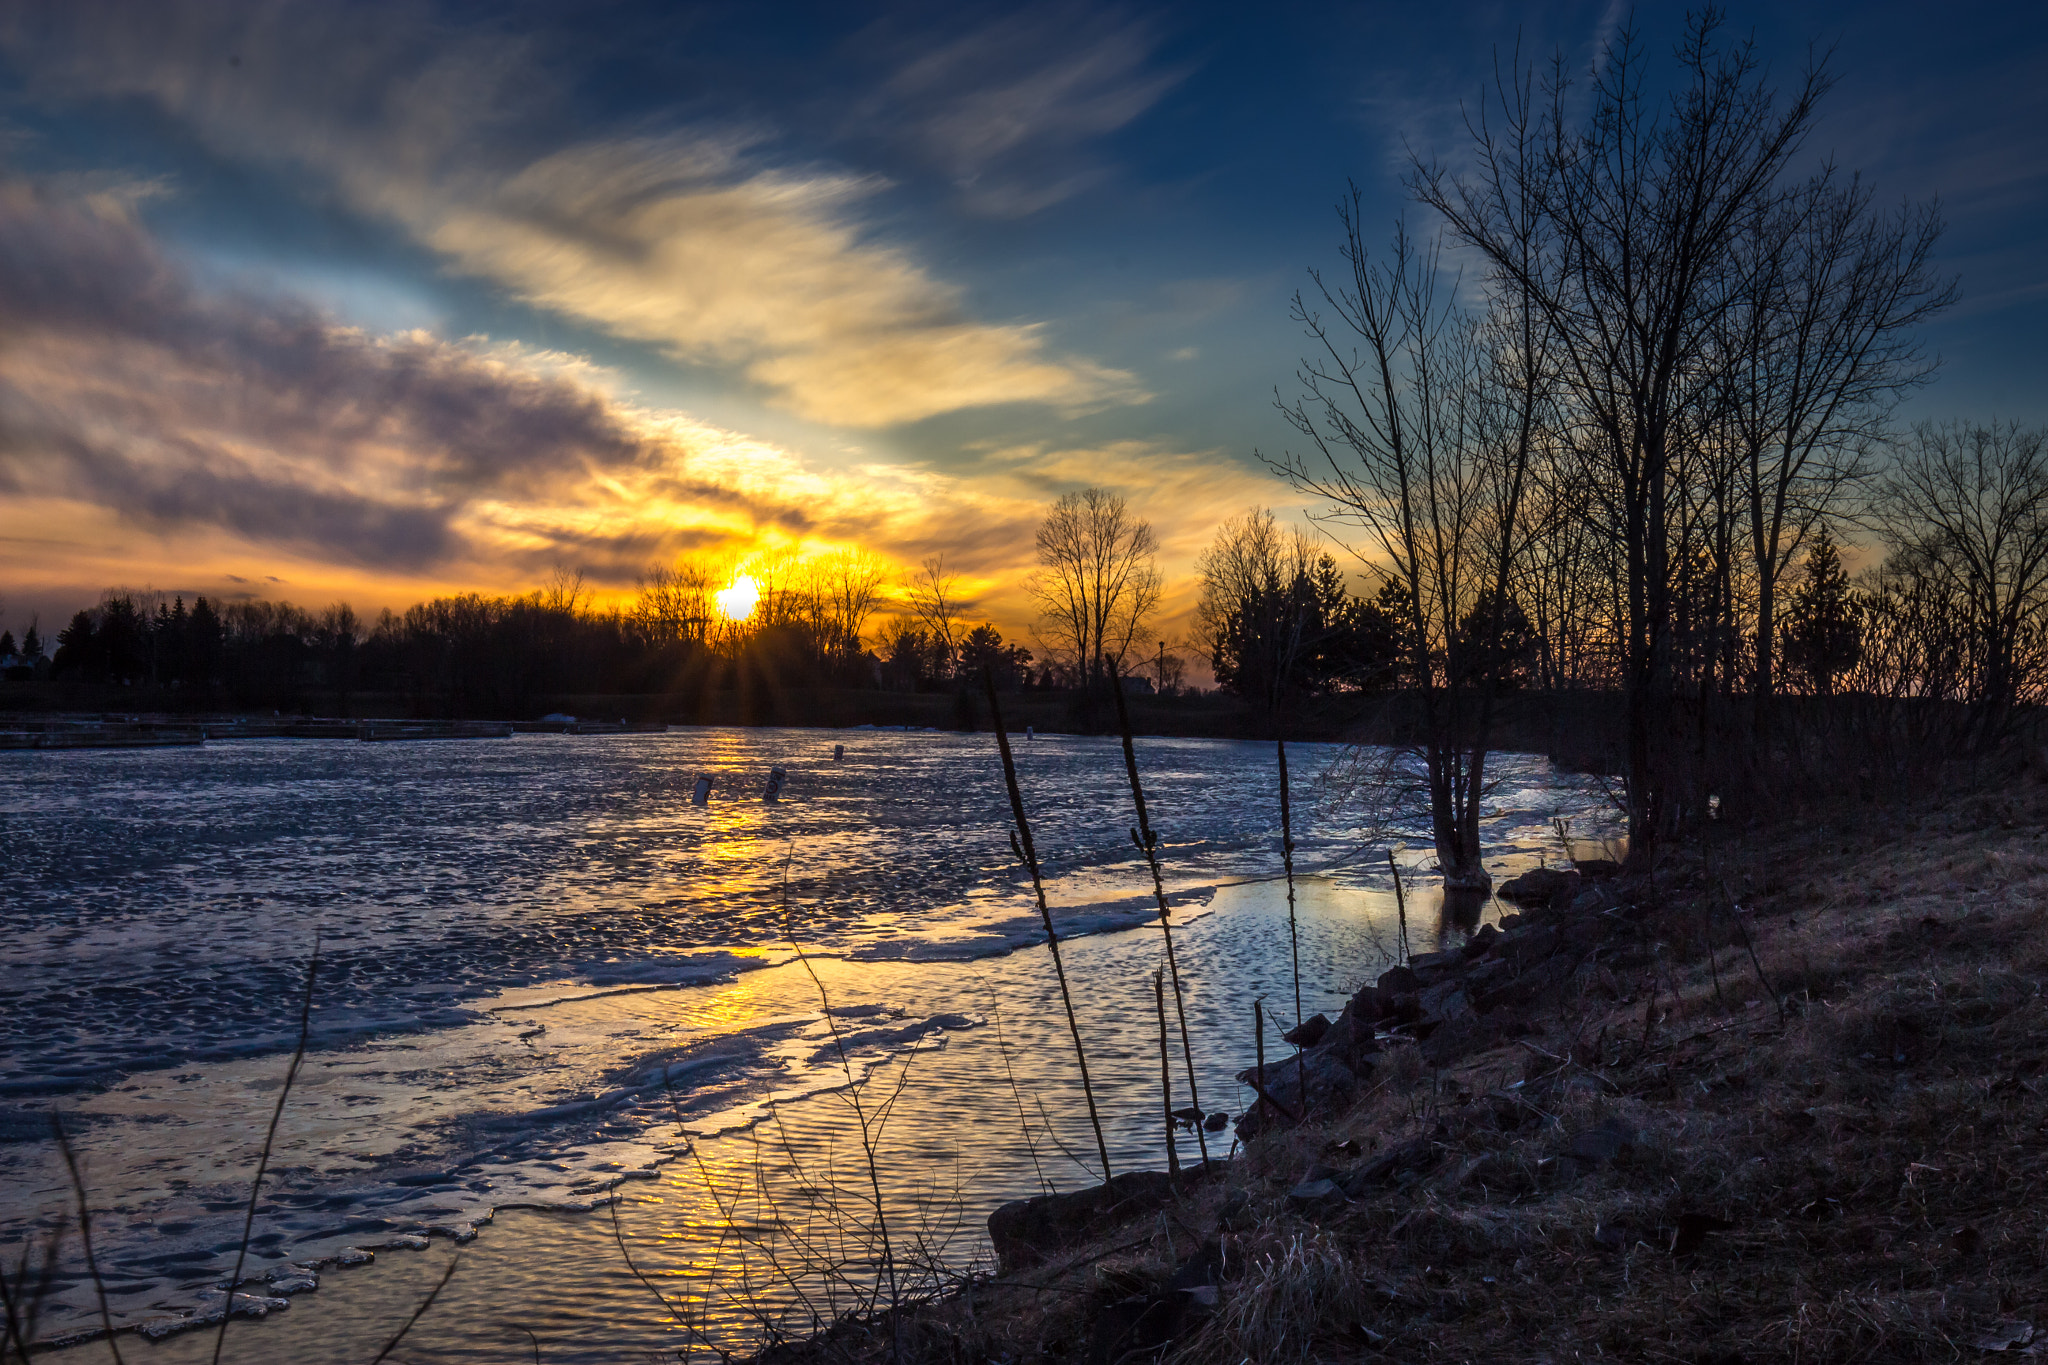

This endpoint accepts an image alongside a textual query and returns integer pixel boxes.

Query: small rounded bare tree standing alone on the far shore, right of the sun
[1030,489,1161,686]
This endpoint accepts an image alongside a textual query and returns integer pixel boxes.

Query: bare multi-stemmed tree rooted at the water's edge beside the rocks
[1274,213,1548,888]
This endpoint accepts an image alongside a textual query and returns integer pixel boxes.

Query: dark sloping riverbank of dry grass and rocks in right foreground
[762,765,2048,1365]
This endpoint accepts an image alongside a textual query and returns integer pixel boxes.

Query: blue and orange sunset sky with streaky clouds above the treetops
[0,0,2048,646]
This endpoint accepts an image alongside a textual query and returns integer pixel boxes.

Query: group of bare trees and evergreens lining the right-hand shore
[1204,12,2048,884]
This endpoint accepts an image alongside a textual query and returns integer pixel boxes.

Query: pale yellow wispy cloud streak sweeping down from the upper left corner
[0,0,1145,428]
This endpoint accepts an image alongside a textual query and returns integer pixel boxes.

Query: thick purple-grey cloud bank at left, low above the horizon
[0,182,823,569]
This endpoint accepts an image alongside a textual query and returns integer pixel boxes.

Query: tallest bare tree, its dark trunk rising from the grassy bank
[1411,10,1829,866]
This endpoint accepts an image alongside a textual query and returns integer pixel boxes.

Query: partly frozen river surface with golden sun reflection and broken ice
[0,729,1606,1363]
